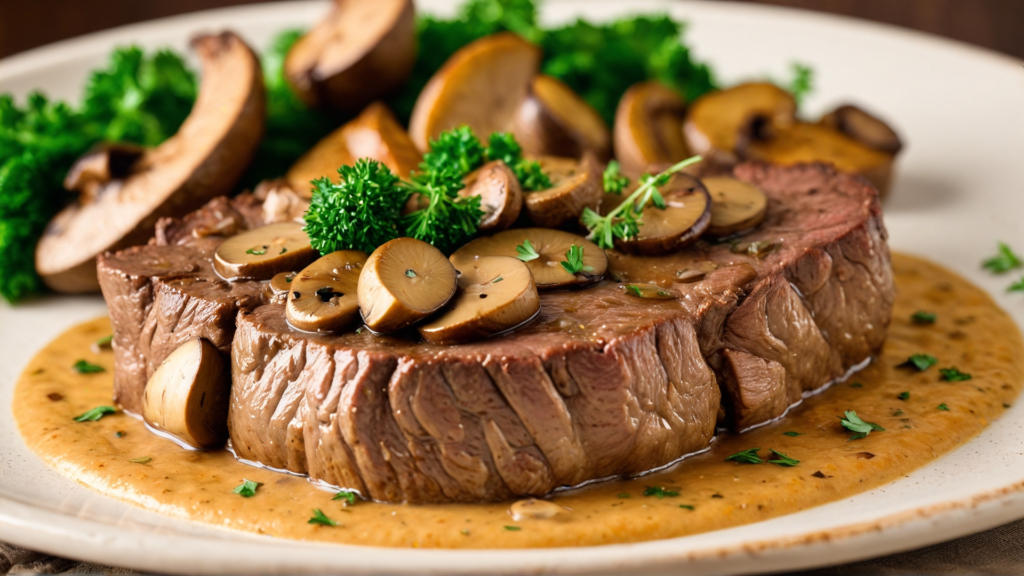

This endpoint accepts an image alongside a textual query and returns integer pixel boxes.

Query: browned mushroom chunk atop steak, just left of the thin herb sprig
[523,153,604,228]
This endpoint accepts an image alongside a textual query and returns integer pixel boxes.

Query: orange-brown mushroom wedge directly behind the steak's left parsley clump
[286,102,422,198]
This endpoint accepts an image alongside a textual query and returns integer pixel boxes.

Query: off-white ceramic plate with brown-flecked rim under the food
[0,0,1024,574]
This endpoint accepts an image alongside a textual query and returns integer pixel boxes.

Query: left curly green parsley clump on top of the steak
[303,159,409,254]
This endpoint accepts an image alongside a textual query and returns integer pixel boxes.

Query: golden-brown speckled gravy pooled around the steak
[13,254,1024,548]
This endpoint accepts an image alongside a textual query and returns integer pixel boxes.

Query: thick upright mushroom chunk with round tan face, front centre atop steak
[357,238,458,333]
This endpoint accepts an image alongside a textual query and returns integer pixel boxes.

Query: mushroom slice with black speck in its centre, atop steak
[285,250,367,333]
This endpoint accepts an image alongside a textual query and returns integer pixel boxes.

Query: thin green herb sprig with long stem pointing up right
[582,156,701,250]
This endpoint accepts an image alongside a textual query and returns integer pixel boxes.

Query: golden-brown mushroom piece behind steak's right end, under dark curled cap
[749,123,895,198]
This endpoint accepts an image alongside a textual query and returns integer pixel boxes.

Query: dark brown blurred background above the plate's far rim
[0,0,1024,57]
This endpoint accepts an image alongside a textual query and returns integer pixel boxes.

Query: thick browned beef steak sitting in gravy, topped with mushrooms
[98,159,894,502]
